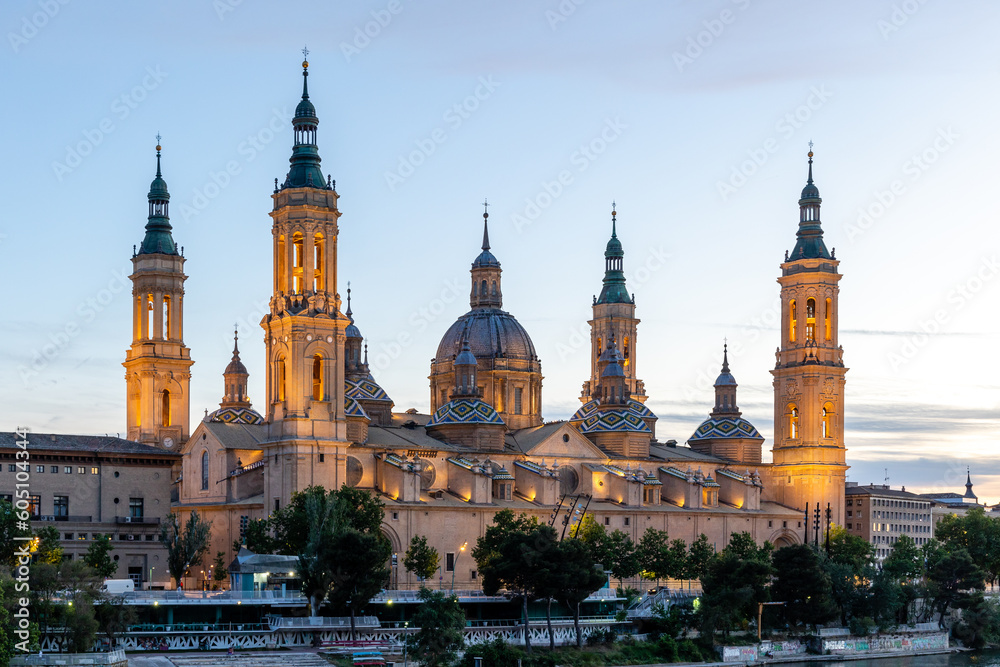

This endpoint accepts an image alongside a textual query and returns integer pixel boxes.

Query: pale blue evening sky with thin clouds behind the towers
[0,0,1000,503]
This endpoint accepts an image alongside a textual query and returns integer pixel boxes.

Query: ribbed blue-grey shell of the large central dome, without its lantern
[435,308,538,361]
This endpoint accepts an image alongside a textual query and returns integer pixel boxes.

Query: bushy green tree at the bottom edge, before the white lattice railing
[407,588,465,667]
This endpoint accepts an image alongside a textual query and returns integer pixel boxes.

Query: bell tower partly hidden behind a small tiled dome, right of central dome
[580,203,647,403]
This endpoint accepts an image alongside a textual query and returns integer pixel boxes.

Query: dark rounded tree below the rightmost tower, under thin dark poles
[771,544,837,627]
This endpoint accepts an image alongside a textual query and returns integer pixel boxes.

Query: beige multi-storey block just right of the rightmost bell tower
[844,482,935,562]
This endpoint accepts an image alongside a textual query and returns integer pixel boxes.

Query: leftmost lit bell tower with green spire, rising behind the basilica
[122,142,194,449]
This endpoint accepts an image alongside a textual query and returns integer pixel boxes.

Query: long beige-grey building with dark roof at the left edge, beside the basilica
[0,433,180,588]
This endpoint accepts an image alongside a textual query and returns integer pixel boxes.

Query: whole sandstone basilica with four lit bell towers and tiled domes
[116,57,847,588]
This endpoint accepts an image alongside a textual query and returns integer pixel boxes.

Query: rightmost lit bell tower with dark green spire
[771,150,848,525]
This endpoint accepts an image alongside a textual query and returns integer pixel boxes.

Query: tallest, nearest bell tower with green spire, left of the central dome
[261,50,350,510]
